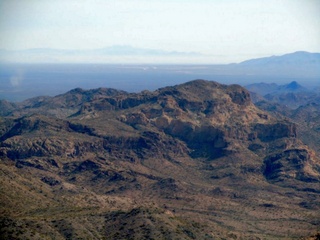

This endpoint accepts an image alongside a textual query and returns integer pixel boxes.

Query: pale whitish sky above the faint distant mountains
[0,0,320,63]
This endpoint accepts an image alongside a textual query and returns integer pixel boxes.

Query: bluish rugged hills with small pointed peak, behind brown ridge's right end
[246,81,320,152]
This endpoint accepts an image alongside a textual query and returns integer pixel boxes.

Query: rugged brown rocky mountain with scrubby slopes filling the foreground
[0,80,320,239]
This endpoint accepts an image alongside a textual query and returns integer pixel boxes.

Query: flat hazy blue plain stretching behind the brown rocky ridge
[0,64,320,101]
